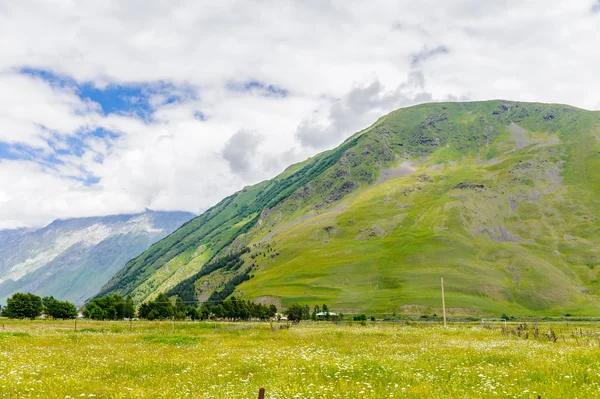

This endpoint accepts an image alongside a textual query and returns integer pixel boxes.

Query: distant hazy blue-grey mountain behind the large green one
[0,211,194,304]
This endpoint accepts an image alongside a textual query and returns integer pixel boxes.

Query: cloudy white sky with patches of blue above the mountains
[0,0,600,229]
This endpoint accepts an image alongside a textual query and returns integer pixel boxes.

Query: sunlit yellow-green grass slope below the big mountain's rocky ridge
[238,104,600,316]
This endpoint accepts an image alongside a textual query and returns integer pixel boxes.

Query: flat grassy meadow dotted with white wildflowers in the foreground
[0,320,600,399]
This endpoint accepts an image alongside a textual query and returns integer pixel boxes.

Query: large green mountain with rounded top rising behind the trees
[100,100,600,316]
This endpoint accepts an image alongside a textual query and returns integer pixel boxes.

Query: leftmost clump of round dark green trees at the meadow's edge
[2,292,77,319]
